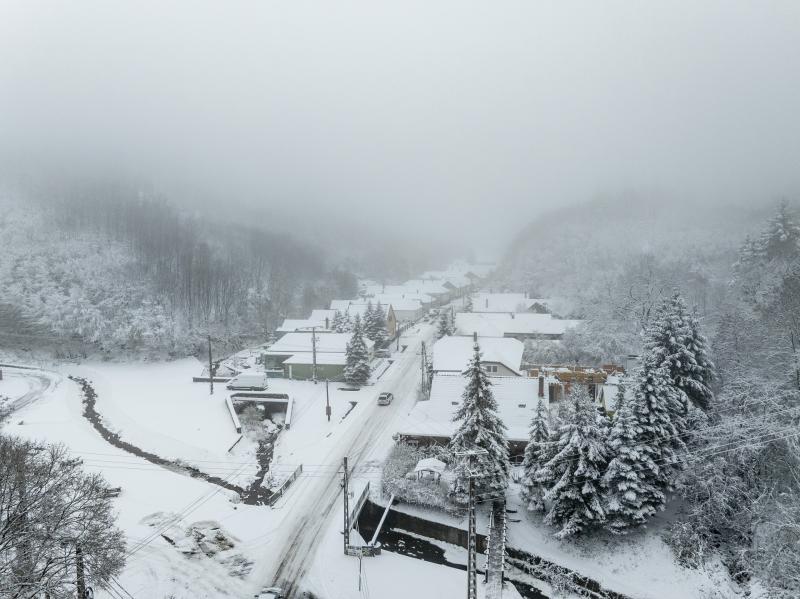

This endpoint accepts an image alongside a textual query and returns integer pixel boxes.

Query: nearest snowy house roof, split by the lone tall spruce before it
[399,374,547,441]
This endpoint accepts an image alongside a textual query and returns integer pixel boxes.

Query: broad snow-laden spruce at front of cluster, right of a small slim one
[537,385,607,538]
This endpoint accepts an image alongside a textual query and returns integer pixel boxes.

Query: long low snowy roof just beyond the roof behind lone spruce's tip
[456,312,582,337]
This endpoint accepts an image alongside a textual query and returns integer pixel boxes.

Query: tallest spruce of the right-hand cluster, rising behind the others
[645,293,714,414]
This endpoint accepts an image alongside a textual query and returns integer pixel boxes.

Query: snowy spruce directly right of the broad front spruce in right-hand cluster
[603,384,665,534]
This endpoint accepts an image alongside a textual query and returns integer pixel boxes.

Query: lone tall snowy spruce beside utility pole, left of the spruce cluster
[448,343,511,505]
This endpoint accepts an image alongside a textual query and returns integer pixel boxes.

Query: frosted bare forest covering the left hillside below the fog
[0,185,356,357]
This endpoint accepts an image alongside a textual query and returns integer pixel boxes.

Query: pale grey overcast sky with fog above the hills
[0,0,800,248]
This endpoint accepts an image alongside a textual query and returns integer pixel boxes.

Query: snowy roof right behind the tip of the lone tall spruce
[433,335,525,372]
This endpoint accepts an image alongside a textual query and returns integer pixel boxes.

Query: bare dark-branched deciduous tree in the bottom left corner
[0,436,125,599]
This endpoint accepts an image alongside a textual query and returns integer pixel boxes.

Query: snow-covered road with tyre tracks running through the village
[252,324,435,598]
